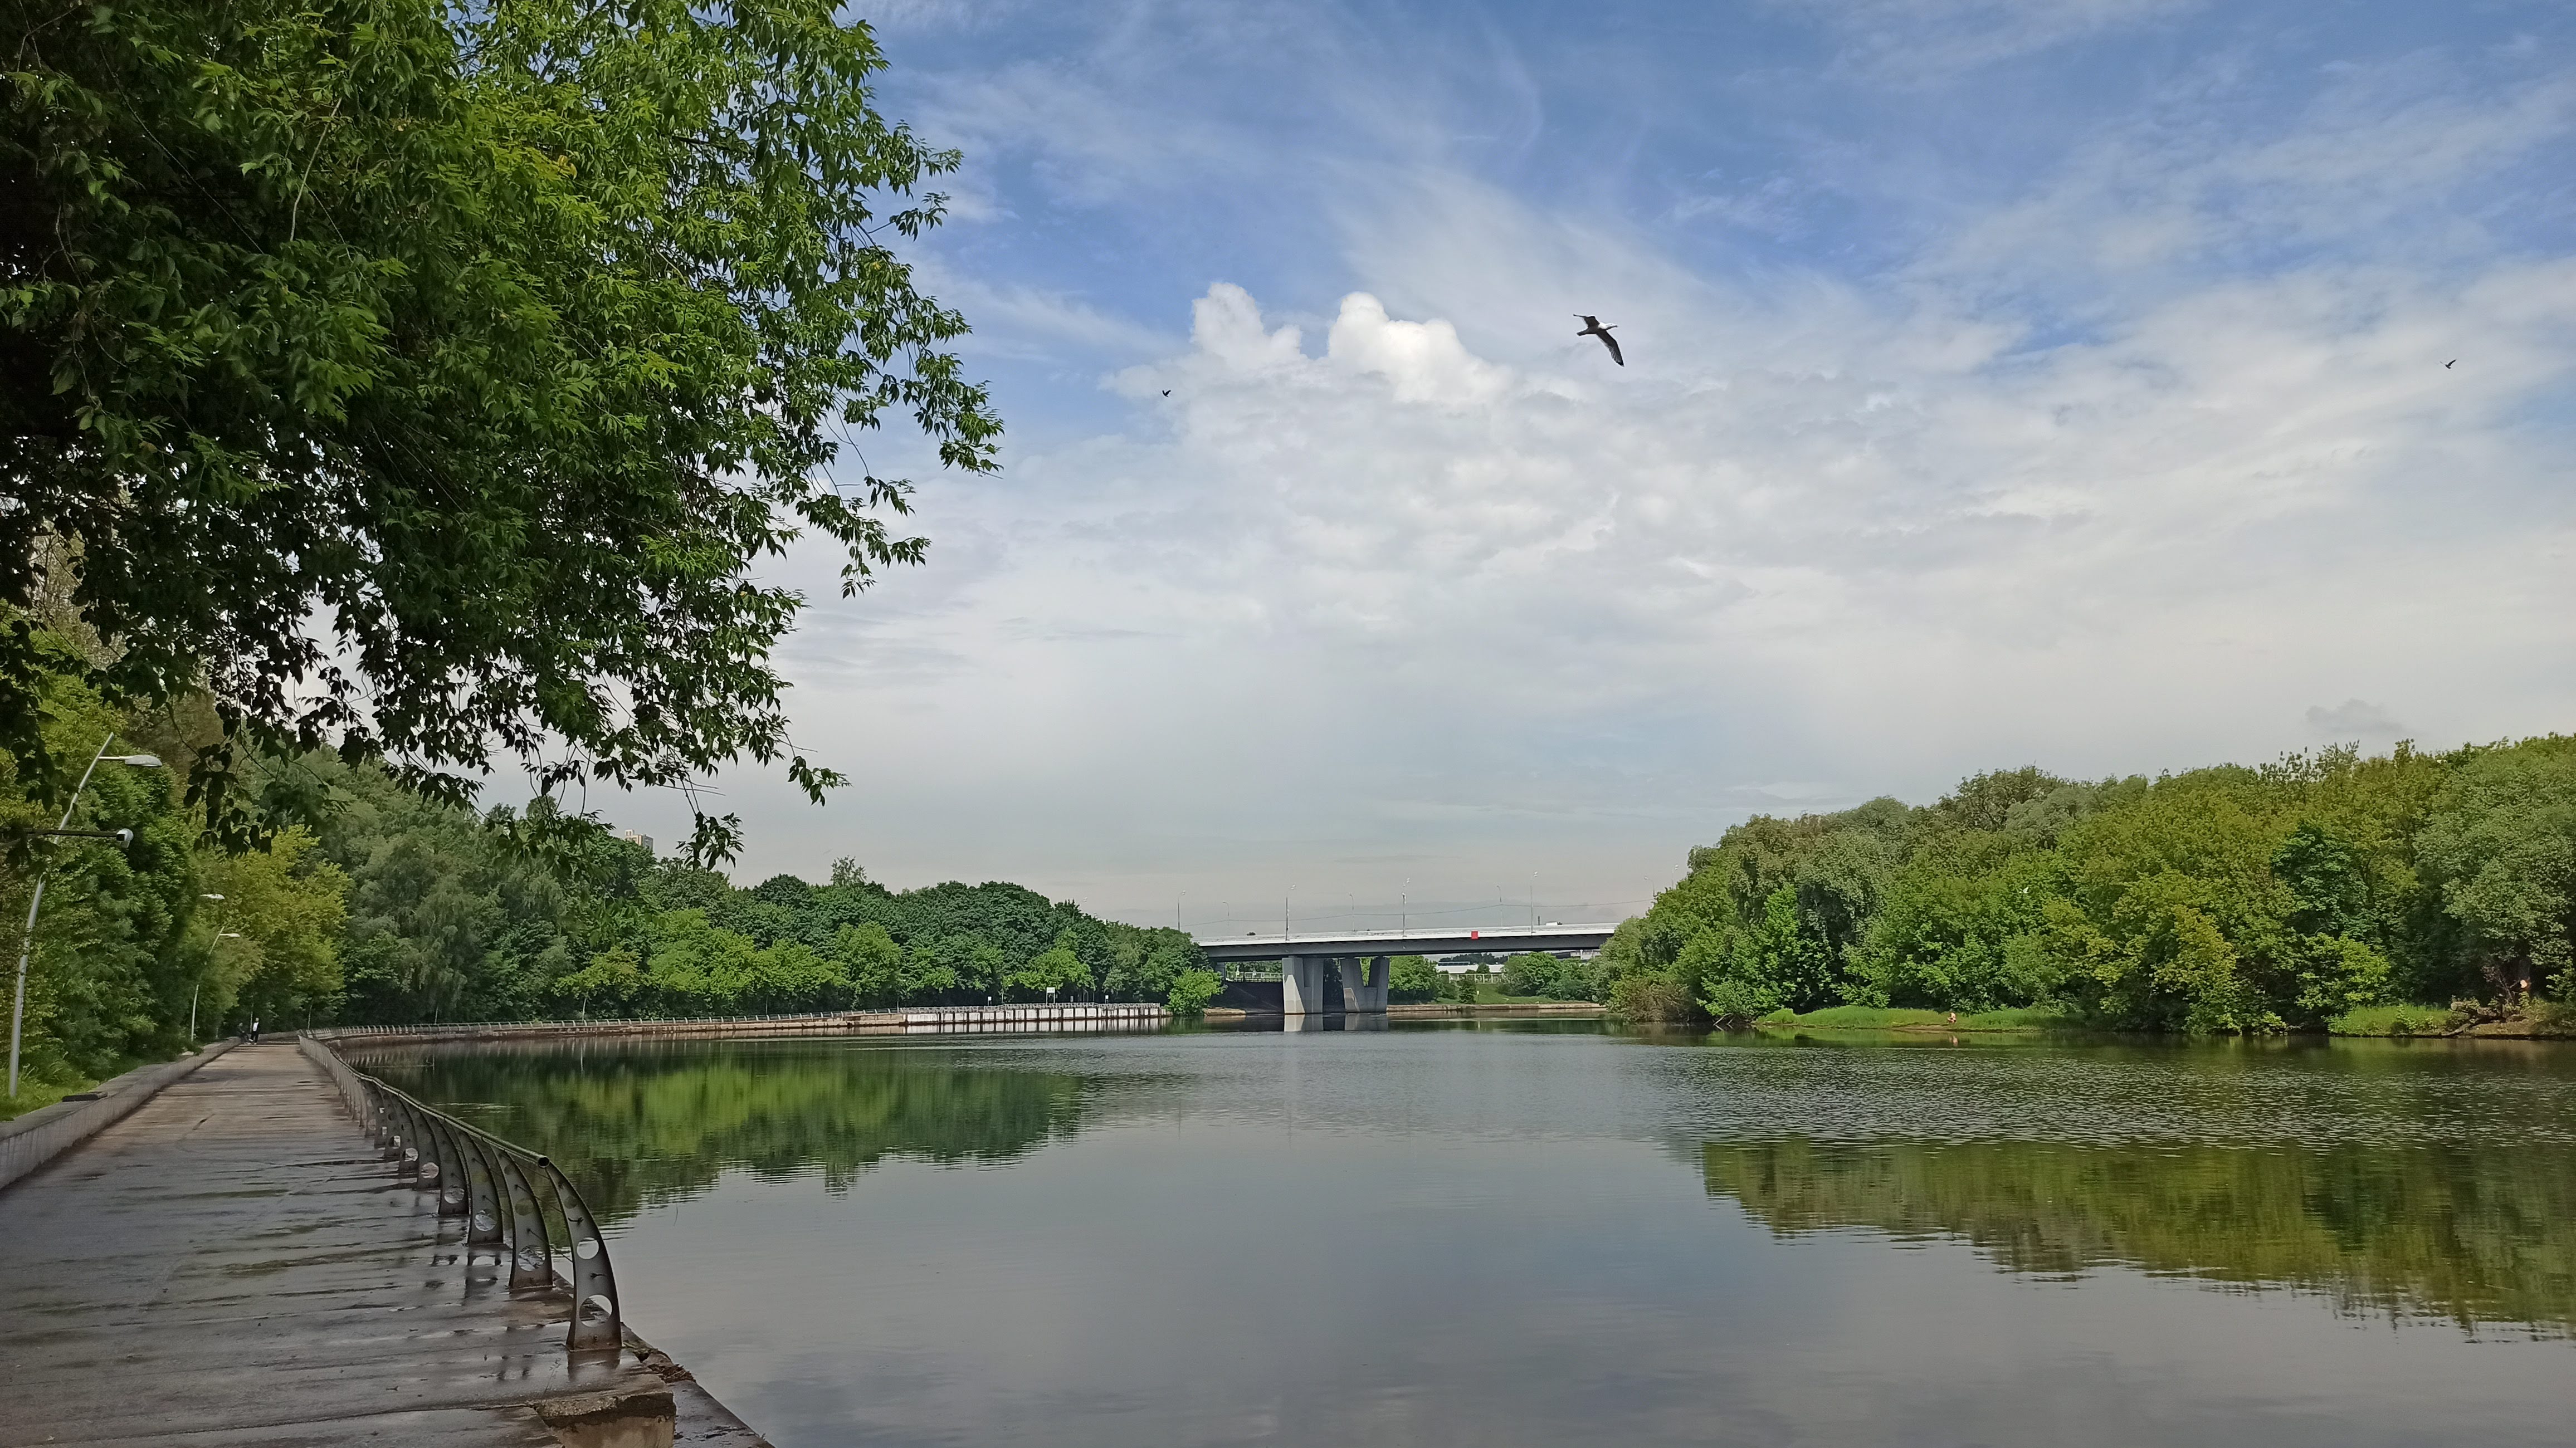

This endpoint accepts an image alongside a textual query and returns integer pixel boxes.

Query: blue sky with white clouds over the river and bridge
[611,0,2576,925]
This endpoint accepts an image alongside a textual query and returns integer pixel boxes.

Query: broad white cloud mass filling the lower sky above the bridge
[685,239,2576,904]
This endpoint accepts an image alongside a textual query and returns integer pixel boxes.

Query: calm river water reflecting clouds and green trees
[381,1023,2576,1448]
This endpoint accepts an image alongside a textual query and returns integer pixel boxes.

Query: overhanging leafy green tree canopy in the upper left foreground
[0,0,999,858]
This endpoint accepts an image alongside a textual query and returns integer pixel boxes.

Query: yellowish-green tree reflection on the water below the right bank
[1702,1139,2576,1337]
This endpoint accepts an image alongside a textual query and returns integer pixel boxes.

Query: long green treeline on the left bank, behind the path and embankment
[0,649,1216,1108]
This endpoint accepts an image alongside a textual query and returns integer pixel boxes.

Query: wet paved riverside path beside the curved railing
[0,1041,675,1448]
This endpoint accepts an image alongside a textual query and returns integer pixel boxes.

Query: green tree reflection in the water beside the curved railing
[363,1041,1085,1221]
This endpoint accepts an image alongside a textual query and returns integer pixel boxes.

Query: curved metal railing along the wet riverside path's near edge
[296,1033,626,1353]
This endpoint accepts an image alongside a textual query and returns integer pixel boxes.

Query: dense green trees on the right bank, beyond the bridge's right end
[1602,735,2576,1031]
